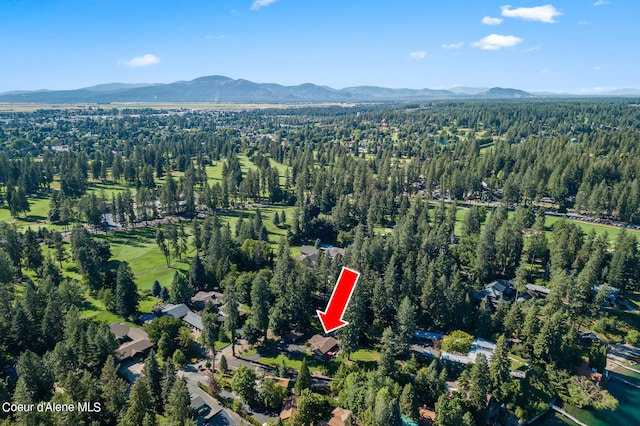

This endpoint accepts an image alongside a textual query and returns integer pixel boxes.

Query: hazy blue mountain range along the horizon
[0,76,640,104]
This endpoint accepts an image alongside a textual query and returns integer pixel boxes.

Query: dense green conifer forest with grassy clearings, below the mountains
[0,99,640,426]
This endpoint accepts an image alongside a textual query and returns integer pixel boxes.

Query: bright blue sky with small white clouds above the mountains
[0,0,640,93]
